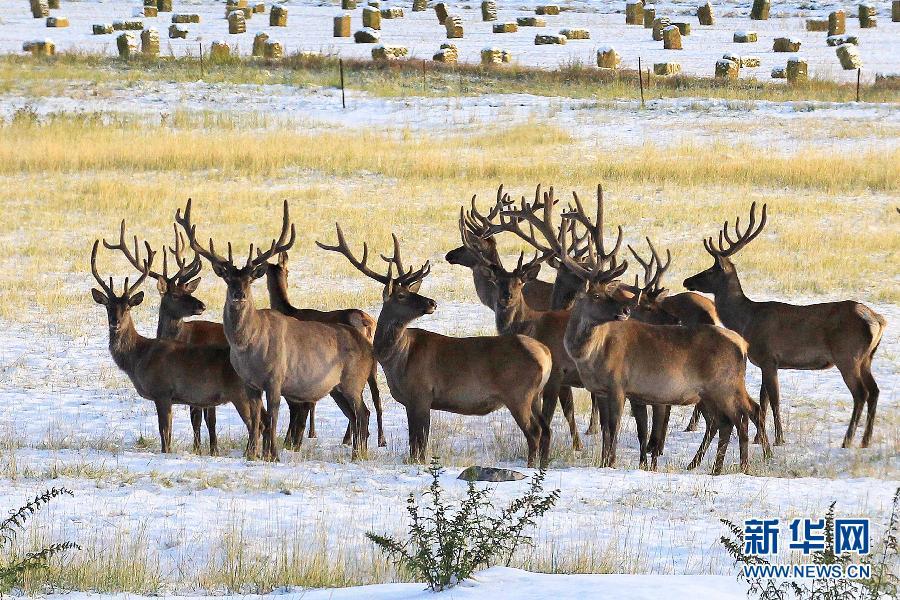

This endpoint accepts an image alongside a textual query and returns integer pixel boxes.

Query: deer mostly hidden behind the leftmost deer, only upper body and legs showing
[103,219,228,456]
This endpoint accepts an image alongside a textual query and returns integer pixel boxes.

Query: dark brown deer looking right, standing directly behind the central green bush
[316,224,553,467]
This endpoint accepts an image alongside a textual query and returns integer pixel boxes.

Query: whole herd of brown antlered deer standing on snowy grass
[91,186,885,474]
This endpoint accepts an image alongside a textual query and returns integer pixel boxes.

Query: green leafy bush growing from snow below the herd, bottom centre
[366,459,559,592]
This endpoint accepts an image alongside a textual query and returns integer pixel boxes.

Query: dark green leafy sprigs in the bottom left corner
[0,488,81,593]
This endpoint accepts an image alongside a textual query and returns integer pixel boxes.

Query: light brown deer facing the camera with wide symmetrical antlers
[175,199,375,461]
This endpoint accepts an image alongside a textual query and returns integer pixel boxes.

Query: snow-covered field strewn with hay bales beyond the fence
[0,0,900,82]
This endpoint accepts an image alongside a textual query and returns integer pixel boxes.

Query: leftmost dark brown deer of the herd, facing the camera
[91,240,262,460]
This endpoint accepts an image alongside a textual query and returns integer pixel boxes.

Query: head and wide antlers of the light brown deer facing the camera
[175,199,297,305]
